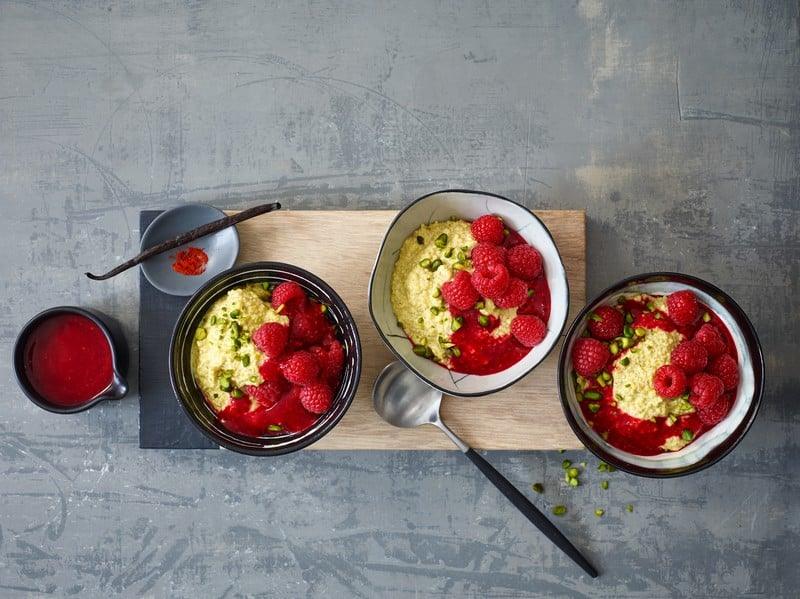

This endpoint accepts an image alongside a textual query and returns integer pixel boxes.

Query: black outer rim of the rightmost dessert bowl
[558,271,765,478]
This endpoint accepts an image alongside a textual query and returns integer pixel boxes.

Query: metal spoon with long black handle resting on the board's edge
[372,362,598,578]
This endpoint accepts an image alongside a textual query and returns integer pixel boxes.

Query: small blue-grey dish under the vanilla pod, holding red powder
[141,204,239,296]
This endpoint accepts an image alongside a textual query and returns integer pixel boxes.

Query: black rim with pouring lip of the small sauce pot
[12,306,128,414]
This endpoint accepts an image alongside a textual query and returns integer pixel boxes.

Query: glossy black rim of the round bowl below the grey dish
[168,261,362,457]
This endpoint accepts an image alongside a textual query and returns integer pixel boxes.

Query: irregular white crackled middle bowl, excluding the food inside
[369,190,569,397]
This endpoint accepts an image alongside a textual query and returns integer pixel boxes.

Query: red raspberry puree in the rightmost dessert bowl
[580,300,737,456]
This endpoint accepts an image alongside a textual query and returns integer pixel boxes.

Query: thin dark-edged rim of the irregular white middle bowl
[367,189,570,398]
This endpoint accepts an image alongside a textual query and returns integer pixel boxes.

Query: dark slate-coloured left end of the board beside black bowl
[139,210,218,449]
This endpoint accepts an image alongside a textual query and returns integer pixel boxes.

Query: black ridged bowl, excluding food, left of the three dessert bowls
[169,262,361,455]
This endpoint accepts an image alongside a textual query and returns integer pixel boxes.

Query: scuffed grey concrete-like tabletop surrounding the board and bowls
[0,0,800,598]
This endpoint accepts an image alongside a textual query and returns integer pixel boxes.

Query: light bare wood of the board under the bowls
[238,210,586,450]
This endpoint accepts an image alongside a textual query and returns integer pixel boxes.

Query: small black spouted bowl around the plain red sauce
[14,306,128,414]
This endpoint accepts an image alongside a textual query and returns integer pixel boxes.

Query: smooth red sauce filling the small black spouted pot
[24,314,113,407]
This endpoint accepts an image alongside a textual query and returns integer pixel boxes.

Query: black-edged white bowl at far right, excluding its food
[558,272,764,478]
